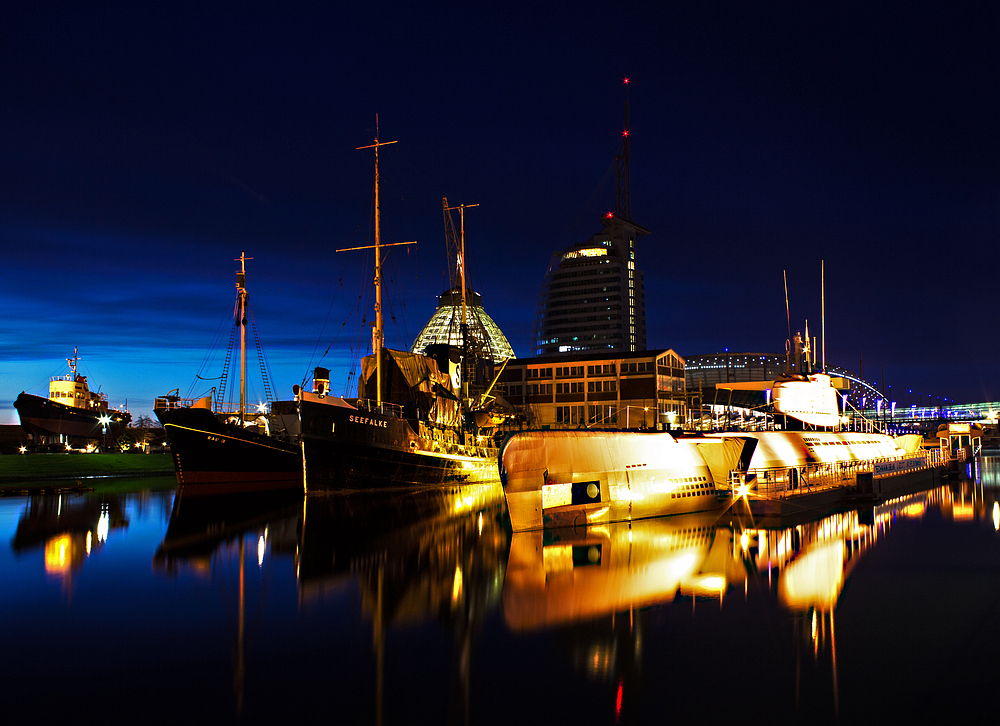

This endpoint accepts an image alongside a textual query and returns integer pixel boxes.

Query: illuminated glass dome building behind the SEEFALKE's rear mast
[410,286,514,363]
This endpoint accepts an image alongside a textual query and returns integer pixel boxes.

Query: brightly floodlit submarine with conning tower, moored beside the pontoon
[499,322,928,532]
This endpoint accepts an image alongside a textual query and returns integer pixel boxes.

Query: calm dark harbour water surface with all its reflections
[0,458,1000,724]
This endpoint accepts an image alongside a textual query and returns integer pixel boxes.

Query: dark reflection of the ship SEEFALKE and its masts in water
[299,484,508,724]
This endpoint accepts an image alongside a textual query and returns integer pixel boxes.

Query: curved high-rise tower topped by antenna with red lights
[534,84,649,355]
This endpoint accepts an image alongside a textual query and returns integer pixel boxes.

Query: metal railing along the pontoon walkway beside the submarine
[747,449,944,499]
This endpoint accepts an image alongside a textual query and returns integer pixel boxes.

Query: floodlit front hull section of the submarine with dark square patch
[500,431,755,532]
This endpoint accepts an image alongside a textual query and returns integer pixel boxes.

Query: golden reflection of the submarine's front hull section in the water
[503,513,732,631]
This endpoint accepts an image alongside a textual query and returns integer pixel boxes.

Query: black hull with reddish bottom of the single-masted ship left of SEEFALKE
[155,408,302,496]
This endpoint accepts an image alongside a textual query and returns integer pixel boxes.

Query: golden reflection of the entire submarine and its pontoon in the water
[502,472,1000,718]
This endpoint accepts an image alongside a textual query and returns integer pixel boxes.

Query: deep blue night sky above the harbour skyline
[0,0,1000,423]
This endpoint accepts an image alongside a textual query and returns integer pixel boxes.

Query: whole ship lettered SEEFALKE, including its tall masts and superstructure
[296,132,502,494]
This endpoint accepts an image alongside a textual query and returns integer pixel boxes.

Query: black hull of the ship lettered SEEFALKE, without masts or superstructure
[299,400,500,493]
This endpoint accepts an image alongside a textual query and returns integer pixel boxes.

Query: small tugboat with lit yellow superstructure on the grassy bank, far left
[14,348,132,448]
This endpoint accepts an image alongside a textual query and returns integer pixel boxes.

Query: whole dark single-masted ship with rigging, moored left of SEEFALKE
[153,252,302,497]
